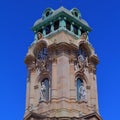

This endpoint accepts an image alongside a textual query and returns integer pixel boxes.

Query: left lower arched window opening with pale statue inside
[40,78,49,101]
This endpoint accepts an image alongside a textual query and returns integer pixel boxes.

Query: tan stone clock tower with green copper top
[24,7,102,120]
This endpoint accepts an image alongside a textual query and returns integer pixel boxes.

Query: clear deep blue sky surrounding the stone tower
[0,0,120,120]
